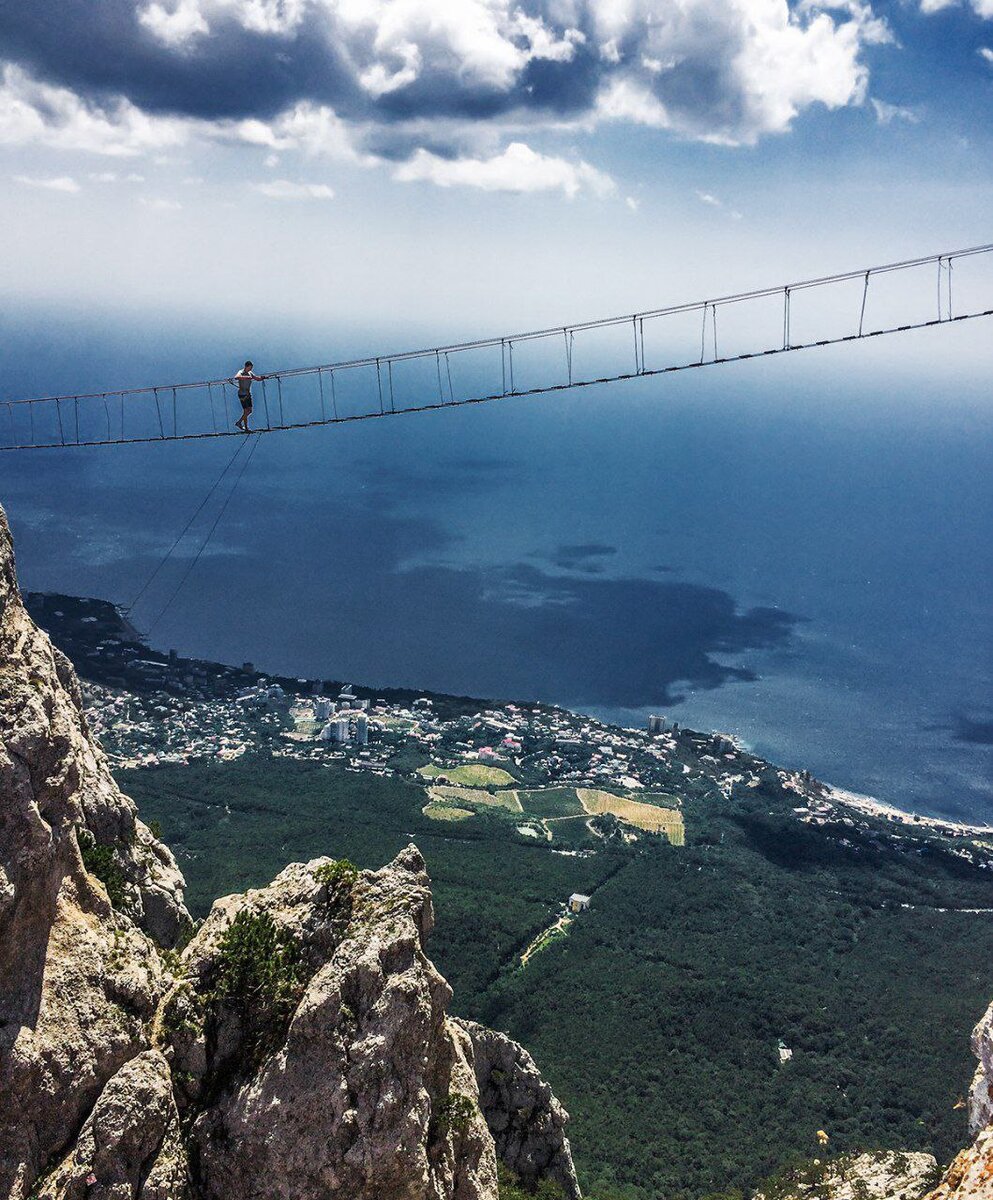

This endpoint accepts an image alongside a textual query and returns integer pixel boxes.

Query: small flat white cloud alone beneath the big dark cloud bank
[393,142,615,199]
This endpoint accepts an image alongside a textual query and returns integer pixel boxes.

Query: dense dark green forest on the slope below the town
[119,757,993,1200]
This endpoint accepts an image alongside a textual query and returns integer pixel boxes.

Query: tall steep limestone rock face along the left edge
[0,501,189,1200]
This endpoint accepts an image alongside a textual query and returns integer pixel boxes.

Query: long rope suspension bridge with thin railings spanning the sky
[0,244,993,451]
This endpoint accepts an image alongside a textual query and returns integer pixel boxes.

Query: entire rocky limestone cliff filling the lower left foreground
[0,511,578,1200]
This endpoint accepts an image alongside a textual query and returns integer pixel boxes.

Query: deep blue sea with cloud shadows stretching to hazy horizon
[0,311,993,823]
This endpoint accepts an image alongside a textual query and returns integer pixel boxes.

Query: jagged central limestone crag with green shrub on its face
[163,846,497,1200]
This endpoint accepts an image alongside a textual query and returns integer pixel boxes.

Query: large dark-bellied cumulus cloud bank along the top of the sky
[0,0,897,189]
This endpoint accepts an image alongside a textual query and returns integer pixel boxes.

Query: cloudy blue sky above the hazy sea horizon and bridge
[0,0,993,348]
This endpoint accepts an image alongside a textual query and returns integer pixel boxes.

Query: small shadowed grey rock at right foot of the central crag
[459,1020,579,1200]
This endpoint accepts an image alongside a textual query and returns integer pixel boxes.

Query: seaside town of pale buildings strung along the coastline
[26,593,993,866]
